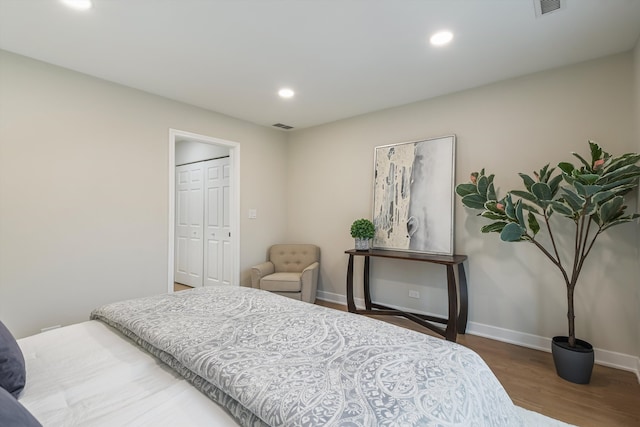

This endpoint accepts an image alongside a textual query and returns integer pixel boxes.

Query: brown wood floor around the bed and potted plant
[175,284,640,427]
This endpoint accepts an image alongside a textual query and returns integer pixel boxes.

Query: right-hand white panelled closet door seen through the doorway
[204,158,231,285]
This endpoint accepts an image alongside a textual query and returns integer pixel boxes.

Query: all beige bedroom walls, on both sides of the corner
[0,48,640,362]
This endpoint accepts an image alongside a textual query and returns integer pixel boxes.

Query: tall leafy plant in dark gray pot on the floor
[456,141,640,384]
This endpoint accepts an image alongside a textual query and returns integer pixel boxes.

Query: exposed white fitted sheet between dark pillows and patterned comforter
[18,321,238,427]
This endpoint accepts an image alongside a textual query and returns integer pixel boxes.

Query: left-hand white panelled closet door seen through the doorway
[175,163,204,286]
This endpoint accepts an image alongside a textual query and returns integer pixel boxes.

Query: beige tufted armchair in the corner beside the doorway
[251,244,320,304]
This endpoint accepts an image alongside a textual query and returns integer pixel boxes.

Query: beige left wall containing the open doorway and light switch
[0,51,286,337]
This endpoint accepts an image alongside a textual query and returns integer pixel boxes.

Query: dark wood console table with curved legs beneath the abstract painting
[345,249,469,342]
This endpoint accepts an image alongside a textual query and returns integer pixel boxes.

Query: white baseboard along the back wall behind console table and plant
[317,291,640,382]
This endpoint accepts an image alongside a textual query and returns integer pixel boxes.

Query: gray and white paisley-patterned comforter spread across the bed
[91,286,522,427]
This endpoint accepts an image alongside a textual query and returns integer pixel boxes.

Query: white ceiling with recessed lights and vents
[0,0,640,129]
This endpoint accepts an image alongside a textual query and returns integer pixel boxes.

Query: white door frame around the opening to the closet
[167,129,240,293]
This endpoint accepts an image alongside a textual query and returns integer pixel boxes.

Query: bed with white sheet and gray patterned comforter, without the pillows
[8,286,566,427]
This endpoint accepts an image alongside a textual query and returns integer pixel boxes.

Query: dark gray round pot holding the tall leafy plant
[551,336,595,384]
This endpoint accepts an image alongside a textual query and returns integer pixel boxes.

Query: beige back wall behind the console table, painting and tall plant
[288,53,640,355]
